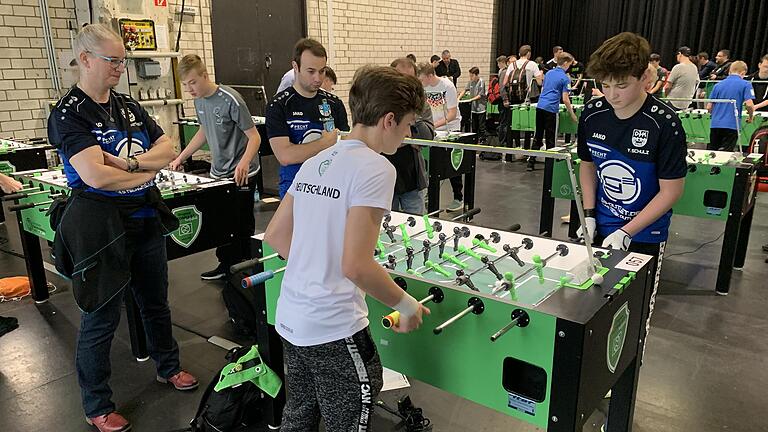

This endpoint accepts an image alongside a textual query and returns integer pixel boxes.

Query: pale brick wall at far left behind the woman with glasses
[0,0,74,138]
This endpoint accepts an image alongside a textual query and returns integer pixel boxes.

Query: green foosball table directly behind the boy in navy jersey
[540,149,764,295]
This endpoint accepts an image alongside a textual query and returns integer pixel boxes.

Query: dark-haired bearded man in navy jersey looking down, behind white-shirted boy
[266,39,349,198]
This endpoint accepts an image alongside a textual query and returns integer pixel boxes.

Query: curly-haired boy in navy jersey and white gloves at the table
[578,33,687,372]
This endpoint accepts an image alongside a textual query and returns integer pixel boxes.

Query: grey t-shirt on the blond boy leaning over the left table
[195,85,259,177]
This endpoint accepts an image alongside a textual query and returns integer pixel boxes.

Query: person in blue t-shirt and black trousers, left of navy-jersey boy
[527,52,578,171]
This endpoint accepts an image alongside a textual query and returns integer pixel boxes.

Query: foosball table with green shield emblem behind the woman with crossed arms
[3,169,239,358]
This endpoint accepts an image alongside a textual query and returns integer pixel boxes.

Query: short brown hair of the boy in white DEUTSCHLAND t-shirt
[349,66,426,126]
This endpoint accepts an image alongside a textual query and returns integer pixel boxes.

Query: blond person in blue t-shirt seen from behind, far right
[707,61,755,151]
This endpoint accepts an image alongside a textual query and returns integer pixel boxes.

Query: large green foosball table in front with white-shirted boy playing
[243,212,653,432]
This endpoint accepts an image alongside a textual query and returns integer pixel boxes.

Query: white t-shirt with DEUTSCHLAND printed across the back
[275,140,396,346]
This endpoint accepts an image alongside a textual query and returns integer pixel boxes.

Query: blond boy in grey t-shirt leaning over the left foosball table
[170,54,261,280]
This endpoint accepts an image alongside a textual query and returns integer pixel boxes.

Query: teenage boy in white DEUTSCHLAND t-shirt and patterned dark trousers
[264,67,429,432]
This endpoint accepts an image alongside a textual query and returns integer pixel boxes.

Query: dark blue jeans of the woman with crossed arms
[75,218,181,417]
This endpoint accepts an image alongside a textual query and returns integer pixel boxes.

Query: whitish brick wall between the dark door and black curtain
[307,0,496,107]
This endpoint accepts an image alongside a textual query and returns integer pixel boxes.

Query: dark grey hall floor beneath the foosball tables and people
[0,157,768,432]
